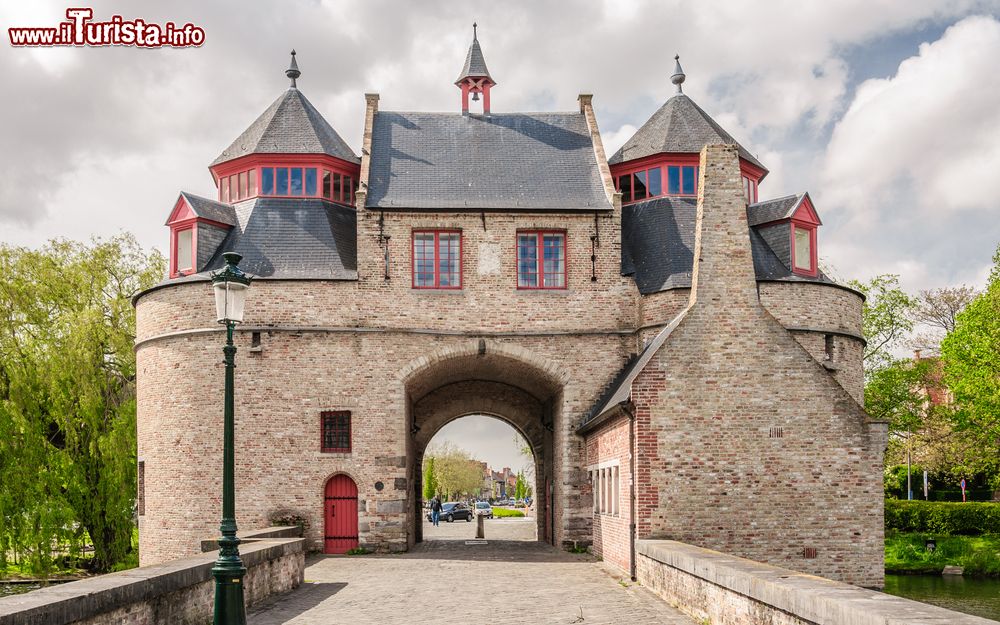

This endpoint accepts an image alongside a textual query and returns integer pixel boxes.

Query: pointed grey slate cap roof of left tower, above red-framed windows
[212,87,360,165]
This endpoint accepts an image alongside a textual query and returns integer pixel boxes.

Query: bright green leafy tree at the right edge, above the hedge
[941,248,1000,472]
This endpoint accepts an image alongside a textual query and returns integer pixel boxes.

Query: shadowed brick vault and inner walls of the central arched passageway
[404,341,562,546]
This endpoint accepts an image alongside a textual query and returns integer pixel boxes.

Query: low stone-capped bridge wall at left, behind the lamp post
[0,538,305,625]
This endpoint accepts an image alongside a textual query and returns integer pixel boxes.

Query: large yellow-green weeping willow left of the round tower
[0,235,165,572]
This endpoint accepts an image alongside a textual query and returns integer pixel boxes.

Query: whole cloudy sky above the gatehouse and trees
[0,0,1000,464]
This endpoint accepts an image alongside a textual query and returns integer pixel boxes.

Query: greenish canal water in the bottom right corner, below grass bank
[885,575,1000,621]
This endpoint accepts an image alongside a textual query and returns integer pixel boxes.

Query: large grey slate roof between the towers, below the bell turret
[366,111,612,210]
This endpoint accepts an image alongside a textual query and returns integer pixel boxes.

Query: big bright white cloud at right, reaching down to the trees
[817,16,1000,290]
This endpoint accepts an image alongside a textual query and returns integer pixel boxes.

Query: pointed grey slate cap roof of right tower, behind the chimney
[608,93,767,173]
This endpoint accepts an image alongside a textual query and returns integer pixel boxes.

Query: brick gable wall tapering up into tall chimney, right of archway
[633,147,884,586]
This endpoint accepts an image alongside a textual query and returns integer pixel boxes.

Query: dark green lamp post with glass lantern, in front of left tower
[212,252,250,625]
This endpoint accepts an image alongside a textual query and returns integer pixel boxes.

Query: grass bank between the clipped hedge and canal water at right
[885,532,1000,577]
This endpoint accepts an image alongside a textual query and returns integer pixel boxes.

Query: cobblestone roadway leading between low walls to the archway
[248,519,694,625]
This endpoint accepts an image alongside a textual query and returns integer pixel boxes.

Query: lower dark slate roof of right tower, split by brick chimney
[622,197,833,295]
